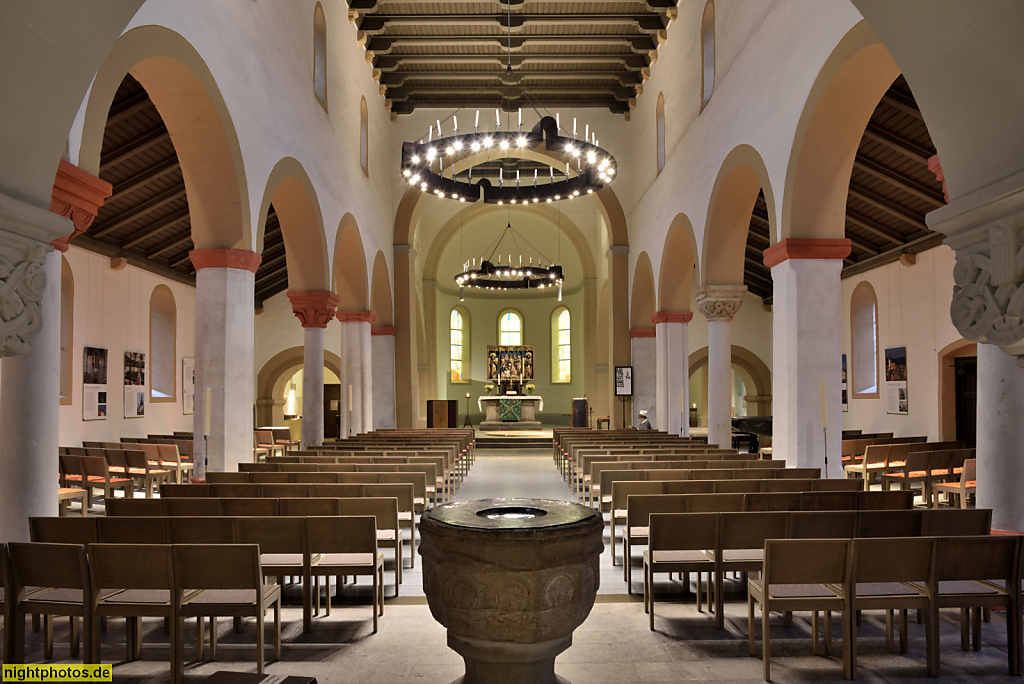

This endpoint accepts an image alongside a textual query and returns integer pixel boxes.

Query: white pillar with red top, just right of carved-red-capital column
[336,311,376,437]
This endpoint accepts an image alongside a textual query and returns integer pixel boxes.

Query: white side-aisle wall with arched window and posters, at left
[59,242,196,446]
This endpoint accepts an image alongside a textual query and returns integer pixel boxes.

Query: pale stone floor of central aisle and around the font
[9,450,1020,684]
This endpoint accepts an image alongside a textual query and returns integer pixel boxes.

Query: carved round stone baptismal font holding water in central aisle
[420,499,604,684]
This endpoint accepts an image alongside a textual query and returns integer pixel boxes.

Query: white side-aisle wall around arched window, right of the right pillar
[843,245,961,439]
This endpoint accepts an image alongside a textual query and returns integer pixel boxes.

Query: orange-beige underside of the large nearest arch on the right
[782,22,900,244]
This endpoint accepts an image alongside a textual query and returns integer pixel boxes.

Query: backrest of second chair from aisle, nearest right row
[852,537,935,583]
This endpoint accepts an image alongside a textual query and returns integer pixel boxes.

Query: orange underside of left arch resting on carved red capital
[254,157,331,292]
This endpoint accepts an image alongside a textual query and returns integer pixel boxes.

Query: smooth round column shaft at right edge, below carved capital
[978,344,1024,532]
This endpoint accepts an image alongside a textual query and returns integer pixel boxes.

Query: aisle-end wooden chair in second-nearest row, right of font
[643,513,719,630]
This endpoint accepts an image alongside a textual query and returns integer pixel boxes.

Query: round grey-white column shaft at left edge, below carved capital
[0,249,60,542]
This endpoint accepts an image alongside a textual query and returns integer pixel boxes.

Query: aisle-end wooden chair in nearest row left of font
[171,544,281,680]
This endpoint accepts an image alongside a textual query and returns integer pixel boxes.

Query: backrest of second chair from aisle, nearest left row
[88,540,174,591]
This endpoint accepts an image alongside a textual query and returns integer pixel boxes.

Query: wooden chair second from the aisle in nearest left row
[88,544,181,671]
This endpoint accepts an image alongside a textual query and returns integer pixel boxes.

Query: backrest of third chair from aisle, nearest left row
[4,542,89,593]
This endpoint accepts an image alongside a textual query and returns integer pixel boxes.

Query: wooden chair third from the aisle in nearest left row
[4,540,96,662]
